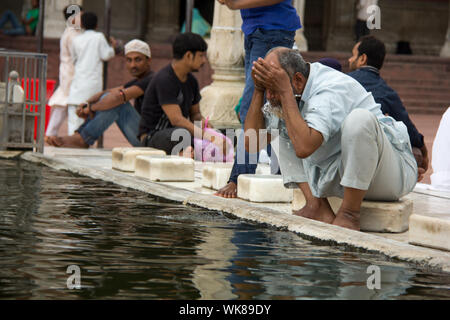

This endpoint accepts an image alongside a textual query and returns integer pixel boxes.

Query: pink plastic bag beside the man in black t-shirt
[194,128,234,162]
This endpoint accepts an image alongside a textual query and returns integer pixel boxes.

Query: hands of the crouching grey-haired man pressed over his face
[252,58,292,95]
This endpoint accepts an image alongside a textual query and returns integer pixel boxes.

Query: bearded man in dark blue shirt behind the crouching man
[348,36,429,181]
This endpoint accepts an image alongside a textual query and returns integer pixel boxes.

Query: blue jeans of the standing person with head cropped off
[229,29,295,183]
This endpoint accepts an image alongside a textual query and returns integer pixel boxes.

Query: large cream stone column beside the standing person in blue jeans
[200,1,245,128]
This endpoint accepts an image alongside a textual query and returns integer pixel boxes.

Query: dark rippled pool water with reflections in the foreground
[0,160,450,299]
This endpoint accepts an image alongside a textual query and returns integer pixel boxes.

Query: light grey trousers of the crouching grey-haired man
[278,109,417,201]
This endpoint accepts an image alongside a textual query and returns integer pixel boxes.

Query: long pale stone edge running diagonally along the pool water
[20,152,450,273]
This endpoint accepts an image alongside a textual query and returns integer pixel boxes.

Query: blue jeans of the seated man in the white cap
[76,95,141,147]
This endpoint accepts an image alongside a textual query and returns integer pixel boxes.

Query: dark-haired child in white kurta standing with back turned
[67,12,114,135]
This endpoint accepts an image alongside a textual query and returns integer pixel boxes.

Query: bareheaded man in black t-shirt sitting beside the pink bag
[139,33,226,157]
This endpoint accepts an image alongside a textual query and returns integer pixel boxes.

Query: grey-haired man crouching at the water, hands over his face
[245,48,418,230]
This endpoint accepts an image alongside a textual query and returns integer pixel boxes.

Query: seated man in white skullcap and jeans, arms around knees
[47,40,153,148]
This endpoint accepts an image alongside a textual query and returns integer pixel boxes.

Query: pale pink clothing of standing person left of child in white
[48,27,80,107]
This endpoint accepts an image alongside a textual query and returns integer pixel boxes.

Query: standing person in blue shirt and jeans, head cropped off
[216,0,301,198]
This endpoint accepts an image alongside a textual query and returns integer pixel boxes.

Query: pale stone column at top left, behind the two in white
[44,0,83,38]
